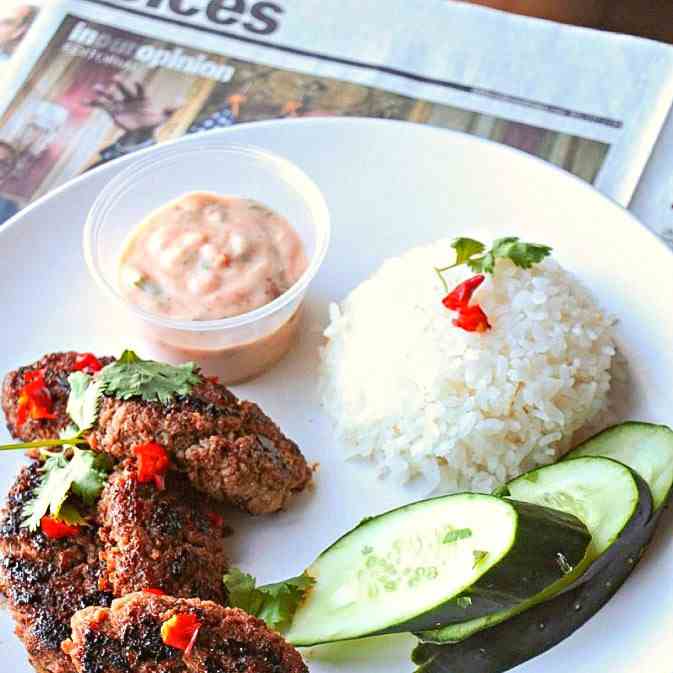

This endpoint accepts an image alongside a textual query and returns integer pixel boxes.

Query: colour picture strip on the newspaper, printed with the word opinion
[0,11,608,226]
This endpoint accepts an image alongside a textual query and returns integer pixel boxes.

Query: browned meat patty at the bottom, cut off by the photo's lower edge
[63,593,308,673]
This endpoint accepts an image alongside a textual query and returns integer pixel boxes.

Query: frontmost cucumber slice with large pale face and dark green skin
[285,493,590,646]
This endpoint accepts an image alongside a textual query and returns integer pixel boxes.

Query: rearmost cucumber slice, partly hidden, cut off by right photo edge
[566,421,673,510]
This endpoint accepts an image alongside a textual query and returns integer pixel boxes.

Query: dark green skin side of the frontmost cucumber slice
[367,500,591,636]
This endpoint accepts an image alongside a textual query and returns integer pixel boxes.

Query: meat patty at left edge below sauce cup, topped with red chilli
[2,351,114,442]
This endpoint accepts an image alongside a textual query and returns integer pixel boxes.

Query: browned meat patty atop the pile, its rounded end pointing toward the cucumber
[89,380,311,514]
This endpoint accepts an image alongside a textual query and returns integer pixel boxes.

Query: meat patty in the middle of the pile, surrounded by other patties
[98,461,228,603]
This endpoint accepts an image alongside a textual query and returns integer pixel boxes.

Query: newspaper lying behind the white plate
[0,0,673,243]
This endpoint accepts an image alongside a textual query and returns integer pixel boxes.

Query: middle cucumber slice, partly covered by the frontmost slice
[418,457,652,643]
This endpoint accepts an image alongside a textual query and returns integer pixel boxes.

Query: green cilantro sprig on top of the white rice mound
[435,236,552,292]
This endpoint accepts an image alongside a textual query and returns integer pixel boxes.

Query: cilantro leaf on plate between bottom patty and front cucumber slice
[224,568,315,631]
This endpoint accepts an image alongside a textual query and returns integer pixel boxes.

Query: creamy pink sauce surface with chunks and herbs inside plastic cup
[119,192,307,320]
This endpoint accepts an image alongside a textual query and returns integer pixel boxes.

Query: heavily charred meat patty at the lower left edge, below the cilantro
[0,464,112,673]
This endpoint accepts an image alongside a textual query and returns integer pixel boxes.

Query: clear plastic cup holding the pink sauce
[84,141,330,384]
